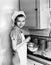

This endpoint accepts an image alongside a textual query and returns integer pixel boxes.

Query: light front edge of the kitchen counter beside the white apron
[28,54,51,65]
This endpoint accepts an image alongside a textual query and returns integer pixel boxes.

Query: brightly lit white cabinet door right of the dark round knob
[40,0,50,29]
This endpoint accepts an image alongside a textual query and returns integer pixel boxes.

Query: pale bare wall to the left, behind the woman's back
[0,0,19,65]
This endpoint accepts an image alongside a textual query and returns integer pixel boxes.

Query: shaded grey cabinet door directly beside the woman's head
[20,0,37,28]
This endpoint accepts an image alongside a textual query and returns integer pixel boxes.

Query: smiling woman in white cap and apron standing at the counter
[11,11,30,65]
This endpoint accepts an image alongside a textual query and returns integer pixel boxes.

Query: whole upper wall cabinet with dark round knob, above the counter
[20,0,49,29]
